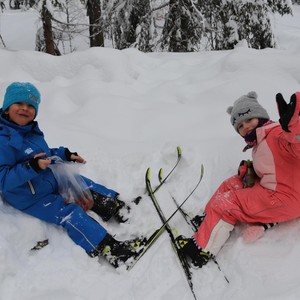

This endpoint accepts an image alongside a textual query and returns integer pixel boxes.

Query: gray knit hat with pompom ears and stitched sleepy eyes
[227,91,270,132]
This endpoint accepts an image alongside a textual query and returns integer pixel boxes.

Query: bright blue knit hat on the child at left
[2,82,41,116]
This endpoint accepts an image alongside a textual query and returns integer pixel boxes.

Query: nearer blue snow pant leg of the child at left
[23,194,107,253]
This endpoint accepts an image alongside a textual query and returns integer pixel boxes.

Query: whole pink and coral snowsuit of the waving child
[194,92,300,255]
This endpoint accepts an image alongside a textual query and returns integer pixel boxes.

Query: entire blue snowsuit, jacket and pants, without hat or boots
[0,110,117,253]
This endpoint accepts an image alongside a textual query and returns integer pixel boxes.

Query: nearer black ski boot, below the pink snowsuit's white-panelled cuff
[176,235,213,268]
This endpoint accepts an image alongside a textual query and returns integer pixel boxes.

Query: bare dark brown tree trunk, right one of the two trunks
[86,0,104,47]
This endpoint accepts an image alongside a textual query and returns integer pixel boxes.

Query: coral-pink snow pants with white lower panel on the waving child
[194,176,299,255]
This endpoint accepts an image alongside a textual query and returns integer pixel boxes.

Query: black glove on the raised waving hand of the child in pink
[276,93,296,132]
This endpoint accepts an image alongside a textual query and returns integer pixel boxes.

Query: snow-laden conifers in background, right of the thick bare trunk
[104,0,292,52]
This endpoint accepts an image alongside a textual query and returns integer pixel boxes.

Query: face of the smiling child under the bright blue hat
[4,102,35,126]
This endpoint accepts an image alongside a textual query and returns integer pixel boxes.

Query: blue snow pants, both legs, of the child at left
[7,177,117,253]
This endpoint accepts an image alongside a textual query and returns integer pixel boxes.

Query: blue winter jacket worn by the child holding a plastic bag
[0,110,72,210]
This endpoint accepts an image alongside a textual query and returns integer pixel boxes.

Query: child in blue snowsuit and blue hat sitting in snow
[0,82,137,267]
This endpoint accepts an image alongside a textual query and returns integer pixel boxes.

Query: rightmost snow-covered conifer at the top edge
[198,0,292,50]
